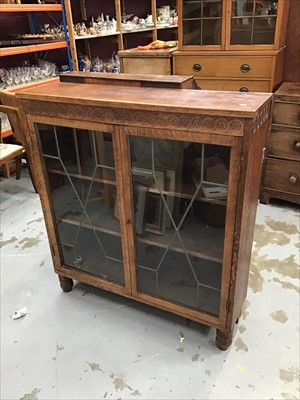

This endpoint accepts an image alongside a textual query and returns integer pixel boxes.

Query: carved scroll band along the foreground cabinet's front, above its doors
[22,100,243,136]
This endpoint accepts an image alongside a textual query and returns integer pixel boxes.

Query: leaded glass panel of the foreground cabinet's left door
[35,123,126,287]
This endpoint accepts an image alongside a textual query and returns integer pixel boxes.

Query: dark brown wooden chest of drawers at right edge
[260,82,300,204]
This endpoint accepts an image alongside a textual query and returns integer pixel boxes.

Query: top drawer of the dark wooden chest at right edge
[272,101,300,127]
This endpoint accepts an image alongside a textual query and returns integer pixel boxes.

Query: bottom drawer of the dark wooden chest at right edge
[263,158,300,194]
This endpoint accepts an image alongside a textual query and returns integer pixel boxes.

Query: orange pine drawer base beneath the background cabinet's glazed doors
[173,49,284,92]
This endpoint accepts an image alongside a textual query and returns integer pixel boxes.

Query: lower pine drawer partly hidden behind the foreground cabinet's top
[195,78,271,92]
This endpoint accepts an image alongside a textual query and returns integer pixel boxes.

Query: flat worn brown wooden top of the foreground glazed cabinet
[16,82,272,118]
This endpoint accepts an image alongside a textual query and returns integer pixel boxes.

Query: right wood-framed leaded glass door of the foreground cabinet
[121,128,239,324]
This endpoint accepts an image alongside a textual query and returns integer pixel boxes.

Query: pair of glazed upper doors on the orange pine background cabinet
[178,0,290,50]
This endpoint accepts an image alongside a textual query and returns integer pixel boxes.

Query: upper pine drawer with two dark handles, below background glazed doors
[173,54,273,79]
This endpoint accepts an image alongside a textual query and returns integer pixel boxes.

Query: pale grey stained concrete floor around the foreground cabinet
[0,171,300,400]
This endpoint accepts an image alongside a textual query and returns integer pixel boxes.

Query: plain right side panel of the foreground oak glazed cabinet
[228,107,270,326]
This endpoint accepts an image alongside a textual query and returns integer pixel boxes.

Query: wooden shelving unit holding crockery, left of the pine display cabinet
[65,0,177,71]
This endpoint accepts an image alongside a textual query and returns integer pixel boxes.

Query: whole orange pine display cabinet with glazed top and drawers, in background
[173,0,290,92]
